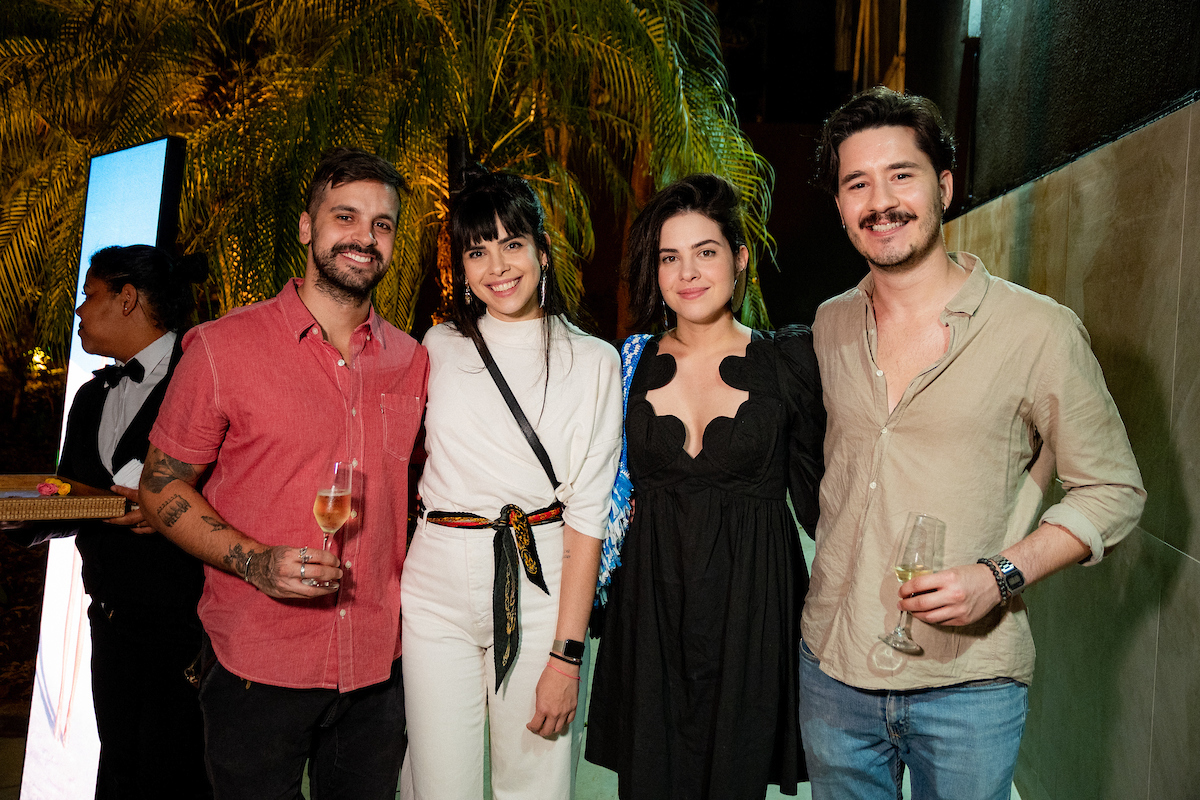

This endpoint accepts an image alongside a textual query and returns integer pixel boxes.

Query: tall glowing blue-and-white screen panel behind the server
[20,138,184,800]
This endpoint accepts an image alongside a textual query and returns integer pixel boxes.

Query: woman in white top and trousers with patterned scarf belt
[402,173,622,800]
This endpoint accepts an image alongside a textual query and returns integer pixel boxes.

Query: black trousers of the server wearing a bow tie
[88,602,212,800]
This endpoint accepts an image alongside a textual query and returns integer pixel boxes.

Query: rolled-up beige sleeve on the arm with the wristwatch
[1033,308,1146,565]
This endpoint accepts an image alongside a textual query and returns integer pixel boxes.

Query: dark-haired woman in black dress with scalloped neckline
[587,175,824,800]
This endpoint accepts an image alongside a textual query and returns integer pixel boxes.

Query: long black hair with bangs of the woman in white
[450,169,582,380]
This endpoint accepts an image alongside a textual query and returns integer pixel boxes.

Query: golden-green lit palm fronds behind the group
[0,0,773,356]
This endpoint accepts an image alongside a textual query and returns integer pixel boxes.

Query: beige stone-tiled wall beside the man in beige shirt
[946,97,1200,800]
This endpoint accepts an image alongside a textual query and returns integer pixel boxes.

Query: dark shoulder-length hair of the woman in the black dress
[625,173,746,331]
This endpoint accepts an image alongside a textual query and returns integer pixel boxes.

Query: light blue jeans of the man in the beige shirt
[800,642,1028,800]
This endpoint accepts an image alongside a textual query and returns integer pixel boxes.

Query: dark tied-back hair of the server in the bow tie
[88,245,208,332]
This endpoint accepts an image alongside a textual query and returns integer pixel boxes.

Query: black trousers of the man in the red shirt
[200,643,408,800]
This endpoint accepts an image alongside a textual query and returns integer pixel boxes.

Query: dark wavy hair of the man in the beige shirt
[814,86,954,197]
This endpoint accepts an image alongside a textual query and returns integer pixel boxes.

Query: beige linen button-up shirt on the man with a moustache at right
[803,253,1146,690]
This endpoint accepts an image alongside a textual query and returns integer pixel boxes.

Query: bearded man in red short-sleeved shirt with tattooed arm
[140,150,428,800]
